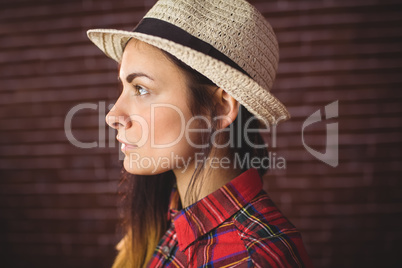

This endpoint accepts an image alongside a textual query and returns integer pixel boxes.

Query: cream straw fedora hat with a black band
[87,0,290,124]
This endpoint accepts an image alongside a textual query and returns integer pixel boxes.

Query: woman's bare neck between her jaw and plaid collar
[173,151,242,208]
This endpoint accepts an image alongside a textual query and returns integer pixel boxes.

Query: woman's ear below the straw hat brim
[215,88,240,129]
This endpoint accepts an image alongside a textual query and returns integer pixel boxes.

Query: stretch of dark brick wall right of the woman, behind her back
[256,1,402,267]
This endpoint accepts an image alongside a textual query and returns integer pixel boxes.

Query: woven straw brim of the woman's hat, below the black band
[87,29,290,125]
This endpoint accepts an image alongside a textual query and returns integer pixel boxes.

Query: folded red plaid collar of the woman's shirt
[169,168,262,252]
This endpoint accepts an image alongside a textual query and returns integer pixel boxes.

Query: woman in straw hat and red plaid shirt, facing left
[88,0,311,267]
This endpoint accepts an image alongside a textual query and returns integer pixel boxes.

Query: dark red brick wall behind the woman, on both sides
[0,0,402,268]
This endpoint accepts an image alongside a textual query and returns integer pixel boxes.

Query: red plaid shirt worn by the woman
[148,169,312,267]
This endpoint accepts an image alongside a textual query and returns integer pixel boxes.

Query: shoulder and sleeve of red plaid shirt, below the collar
[232,190,312,267]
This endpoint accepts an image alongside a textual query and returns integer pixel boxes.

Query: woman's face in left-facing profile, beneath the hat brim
[106,40,196,175]
